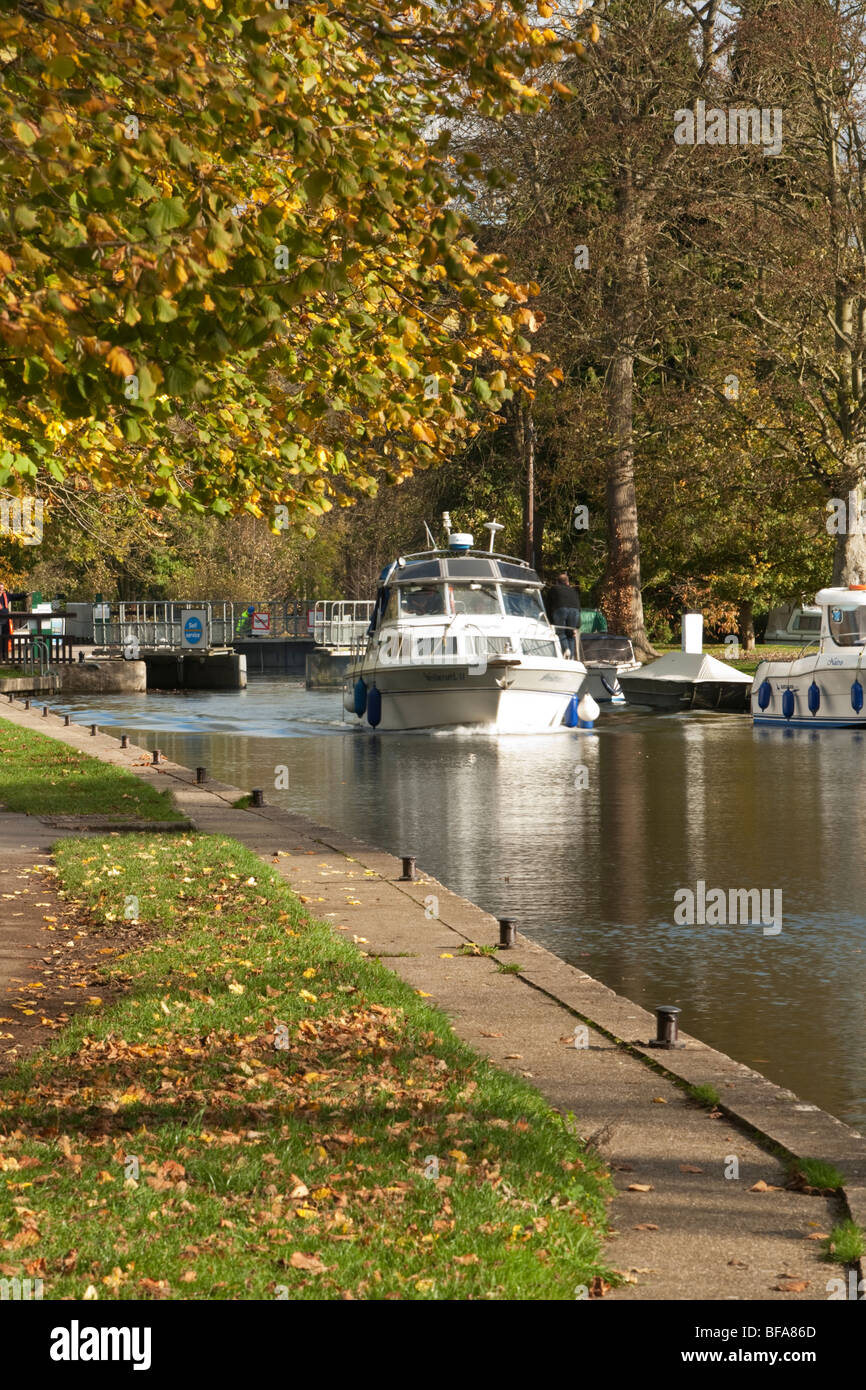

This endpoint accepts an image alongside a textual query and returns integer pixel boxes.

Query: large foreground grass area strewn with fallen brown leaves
[0,835,612,1300]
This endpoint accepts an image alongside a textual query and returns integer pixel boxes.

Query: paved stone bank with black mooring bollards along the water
[3,695,866,1300]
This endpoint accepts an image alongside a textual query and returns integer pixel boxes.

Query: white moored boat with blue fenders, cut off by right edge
[751,584,866,728]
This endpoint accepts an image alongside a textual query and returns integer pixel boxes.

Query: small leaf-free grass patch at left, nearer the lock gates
[0,719,181,820]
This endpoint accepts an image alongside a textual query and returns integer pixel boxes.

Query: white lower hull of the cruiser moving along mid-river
[343,660,585,733]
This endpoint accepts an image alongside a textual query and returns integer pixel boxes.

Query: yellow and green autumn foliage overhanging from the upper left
[0,0,589,525]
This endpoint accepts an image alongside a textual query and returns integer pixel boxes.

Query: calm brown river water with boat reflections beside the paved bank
[45,680,866,1128]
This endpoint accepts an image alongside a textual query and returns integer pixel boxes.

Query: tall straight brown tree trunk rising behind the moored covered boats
[602,170,659,662]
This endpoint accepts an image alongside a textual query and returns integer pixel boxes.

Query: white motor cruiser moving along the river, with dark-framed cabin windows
[343,513,587,733]
